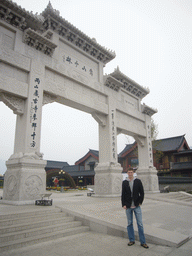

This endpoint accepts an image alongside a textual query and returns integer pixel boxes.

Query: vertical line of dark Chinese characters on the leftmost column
[30,78,40,148]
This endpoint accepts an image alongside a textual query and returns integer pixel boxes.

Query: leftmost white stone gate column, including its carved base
[3,60,46,204]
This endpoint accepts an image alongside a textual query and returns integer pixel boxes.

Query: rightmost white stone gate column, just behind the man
[134,114,159,193]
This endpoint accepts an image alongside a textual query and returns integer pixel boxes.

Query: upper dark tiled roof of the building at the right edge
[153,135,189,152]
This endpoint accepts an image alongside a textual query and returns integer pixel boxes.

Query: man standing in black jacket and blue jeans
[121,168,149,249]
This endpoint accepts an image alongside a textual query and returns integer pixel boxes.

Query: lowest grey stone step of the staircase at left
[0,226,89,252]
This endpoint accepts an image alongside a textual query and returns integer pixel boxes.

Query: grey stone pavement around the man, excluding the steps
[0,190,192,256]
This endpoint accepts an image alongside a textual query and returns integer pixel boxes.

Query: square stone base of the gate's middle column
[94,163,123,197]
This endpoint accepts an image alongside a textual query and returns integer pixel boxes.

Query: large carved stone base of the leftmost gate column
[1,153,47,205]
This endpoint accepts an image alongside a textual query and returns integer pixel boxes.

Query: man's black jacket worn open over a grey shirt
[121,178,144,208]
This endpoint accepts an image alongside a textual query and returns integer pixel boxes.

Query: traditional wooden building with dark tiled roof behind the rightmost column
[118,135,192,177]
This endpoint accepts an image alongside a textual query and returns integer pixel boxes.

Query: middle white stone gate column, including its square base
[95,103,122,197]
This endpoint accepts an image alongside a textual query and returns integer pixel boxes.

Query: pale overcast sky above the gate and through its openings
[0,0,192,173]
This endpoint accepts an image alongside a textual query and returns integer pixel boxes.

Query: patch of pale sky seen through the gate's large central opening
[41,103,98,165]
